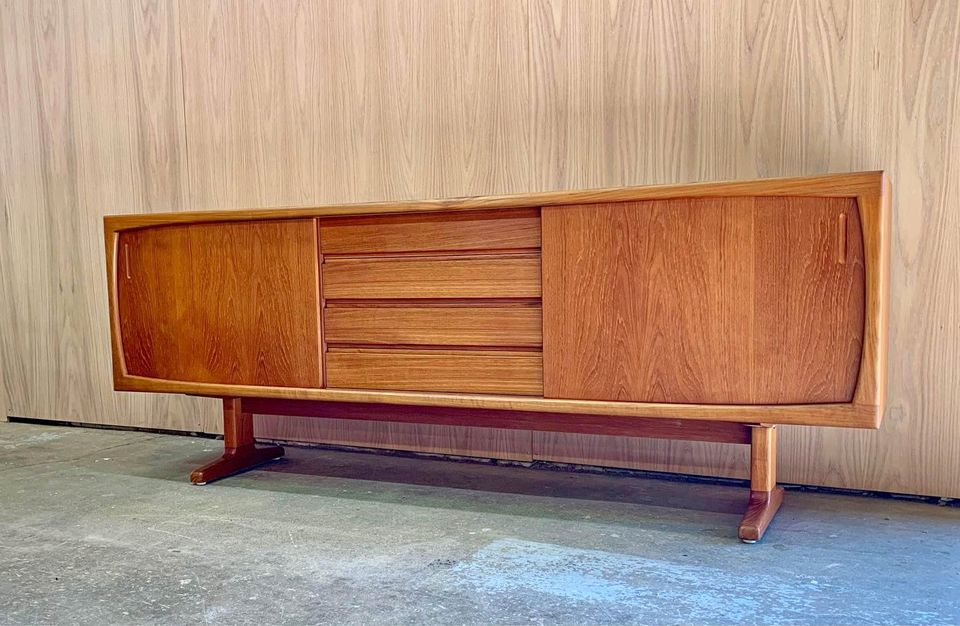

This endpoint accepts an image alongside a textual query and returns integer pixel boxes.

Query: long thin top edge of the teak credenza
[103,170,889,233]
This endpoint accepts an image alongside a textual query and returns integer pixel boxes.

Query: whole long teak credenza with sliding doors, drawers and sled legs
[104,172,890,541]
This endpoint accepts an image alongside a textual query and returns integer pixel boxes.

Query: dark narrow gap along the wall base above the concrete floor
[7,415,960,508]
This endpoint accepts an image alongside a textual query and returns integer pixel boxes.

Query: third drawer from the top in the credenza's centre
[324,305,543,347]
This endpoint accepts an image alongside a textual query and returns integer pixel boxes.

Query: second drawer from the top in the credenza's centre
[322,254,540,300]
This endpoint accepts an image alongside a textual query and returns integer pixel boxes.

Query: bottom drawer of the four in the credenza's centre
[327,349,543,396]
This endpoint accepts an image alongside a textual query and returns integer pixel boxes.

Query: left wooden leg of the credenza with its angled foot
[190,398,283,485]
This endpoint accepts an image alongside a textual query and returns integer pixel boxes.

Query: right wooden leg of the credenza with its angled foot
[739,426,783,543]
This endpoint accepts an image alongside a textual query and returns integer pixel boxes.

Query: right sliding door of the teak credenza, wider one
[542,197,864,404]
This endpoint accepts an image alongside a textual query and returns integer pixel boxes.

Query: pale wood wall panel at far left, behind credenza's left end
[0,1,219,431]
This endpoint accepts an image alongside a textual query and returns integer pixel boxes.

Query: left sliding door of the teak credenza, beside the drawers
[117,220,320,387]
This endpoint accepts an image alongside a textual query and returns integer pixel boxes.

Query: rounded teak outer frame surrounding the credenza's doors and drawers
[104,172,891,428]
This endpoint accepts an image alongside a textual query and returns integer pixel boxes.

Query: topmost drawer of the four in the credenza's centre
[320,209,540,255]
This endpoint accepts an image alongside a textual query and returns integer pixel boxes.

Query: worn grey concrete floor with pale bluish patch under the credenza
[0,423,960,625]
